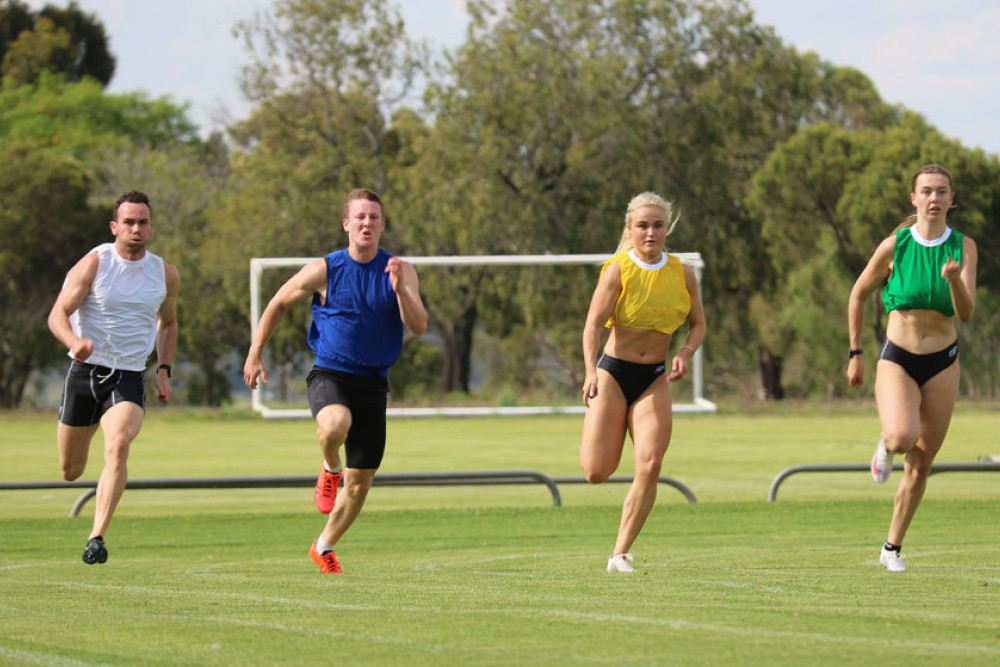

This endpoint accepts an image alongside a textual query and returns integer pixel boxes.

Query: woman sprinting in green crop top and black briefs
[847,164,978,572]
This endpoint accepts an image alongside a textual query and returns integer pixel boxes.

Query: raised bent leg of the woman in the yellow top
[580,368,628,484]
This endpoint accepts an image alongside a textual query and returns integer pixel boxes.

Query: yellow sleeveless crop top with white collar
[601,251,691,334]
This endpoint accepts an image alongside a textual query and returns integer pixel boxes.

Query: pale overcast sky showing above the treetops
[21,0,1000,154]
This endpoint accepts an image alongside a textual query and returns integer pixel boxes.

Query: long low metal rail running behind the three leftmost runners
[0,470,697,517]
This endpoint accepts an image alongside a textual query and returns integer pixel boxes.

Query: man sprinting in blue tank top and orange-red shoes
[243,189,427,574]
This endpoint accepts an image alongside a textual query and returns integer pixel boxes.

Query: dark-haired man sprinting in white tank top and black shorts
[49,190,180,565]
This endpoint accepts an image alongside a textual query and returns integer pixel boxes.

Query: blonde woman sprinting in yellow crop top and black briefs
[580,192,705,572]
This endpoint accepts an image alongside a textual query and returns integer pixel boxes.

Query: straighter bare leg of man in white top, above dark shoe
[90,401,145,537]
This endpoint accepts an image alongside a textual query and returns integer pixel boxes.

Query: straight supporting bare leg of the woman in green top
[888,362,959,544]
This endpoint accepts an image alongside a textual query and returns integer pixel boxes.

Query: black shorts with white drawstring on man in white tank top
[59,360,146,426]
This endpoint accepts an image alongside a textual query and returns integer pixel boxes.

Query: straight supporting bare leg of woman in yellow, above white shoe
[614,375,673,555]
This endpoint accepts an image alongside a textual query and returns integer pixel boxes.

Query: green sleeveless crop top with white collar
[882,226,965,317]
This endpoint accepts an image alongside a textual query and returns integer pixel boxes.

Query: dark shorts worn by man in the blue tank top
[306,366,389,470]
